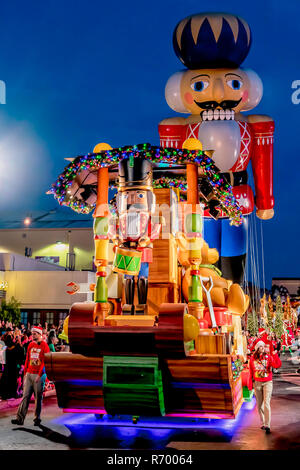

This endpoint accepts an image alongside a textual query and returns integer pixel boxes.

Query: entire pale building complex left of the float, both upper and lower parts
[0,207,122,325]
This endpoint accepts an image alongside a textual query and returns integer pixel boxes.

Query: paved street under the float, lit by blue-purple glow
[0,356,300,450]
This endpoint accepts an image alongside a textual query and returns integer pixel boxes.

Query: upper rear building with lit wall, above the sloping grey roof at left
[0,207,94,271]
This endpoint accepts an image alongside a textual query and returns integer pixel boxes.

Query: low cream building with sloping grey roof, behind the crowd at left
[0,253,95,326]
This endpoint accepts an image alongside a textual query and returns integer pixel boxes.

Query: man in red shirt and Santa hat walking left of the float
[11,326,49,426]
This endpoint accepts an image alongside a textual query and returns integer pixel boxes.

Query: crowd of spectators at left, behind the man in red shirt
[0,320,69,400]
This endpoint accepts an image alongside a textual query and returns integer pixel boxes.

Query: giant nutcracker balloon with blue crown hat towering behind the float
[159,13,274,283]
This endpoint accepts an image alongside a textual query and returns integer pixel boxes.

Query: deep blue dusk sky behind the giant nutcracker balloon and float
[0,0,300,286]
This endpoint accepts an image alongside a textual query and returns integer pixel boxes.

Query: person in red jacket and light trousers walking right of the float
[248,341,281,434]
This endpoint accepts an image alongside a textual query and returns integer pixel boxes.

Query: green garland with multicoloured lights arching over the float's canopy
[50,144,242,225]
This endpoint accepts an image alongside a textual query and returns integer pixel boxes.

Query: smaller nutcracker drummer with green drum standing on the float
[109,156,161,315]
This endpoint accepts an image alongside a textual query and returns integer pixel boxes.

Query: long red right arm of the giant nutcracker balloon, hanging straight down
[248,115,275,219]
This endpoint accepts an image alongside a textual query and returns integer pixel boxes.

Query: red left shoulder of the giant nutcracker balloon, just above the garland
[158,117,186,148]
